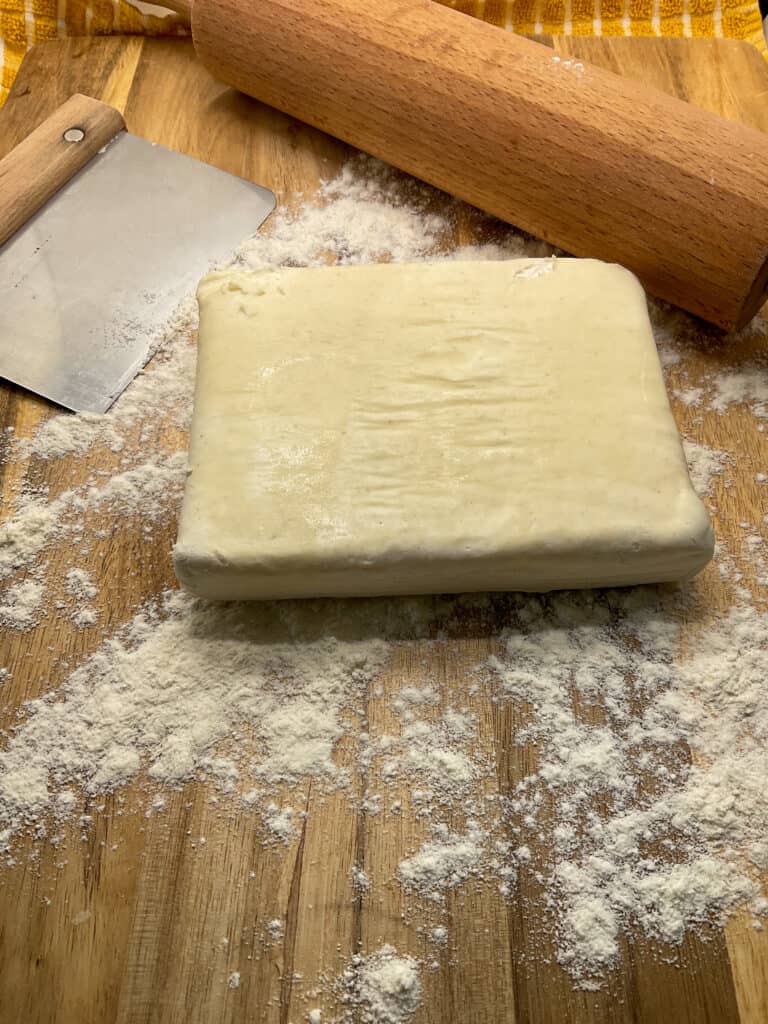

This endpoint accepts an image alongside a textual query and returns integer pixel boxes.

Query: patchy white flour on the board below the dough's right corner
[493,590,768,979]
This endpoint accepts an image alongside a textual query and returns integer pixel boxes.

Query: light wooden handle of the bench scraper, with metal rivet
[0,93,125,245]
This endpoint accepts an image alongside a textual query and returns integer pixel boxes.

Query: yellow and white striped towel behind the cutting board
[0,0,766,105]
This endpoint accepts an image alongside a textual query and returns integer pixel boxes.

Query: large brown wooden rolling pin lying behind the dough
[165,0,768,329]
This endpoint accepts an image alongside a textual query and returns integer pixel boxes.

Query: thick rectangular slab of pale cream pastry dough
[174,259,714,599]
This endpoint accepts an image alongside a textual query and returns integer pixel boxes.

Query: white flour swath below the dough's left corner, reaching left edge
[0,593,389,838]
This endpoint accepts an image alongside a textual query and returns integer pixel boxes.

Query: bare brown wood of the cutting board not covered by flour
[0,32,768,1024]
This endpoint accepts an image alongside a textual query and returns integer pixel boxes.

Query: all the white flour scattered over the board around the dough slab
[0,159,768,999]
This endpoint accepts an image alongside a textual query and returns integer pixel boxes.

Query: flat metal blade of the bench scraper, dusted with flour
[0,131,274,413]
